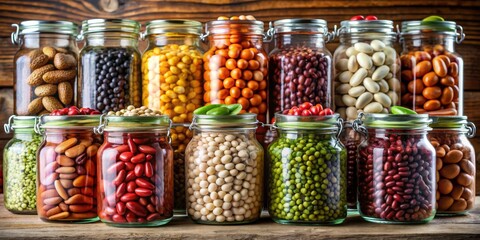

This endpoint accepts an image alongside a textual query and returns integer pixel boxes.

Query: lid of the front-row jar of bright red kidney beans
[95,115,172,134]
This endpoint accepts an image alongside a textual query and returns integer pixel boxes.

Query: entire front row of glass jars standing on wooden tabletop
[4,113,475,226]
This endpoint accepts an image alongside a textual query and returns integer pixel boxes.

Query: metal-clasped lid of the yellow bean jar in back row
[145,19,202,36]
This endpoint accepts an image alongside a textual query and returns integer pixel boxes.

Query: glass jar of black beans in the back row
[78,19,142,113]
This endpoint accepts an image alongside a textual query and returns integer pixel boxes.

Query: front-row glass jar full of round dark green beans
[268,113,347,225]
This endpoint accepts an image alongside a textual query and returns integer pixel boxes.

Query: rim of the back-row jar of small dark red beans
[273,18,328,35]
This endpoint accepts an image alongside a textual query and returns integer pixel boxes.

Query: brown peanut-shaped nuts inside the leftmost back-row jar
[21,46,77,115]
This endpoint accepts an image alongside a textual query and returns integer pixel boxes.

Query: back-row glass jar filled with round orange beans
[203,20,268,142]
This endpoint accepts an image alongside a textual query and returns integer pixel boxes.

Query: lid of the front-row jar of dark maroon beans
[353,113,432,130]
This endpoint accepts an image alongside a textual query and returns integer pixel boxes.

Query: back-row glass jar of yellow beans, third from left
[142,20,203,213]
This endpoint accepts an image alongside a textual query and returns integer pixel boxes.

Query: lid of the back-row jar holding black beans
[81,19,140,35]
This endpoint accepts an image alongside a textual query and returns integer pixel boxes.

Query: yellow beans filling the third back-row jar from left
[142,44,203,123]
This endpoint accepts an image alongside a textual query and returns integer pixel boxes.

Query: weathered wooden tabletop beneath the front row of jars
[0,195,480,240]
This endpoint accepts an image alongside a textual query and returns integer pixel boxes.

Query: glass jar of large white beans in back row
[333,20,400,121]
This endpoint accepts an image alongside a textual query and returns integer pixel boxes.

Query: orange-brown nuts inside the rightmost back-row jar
[400,45,463,116]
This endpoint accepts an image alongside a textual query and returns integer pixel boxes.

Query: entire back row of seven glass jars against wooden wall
[12,19,464,119]
